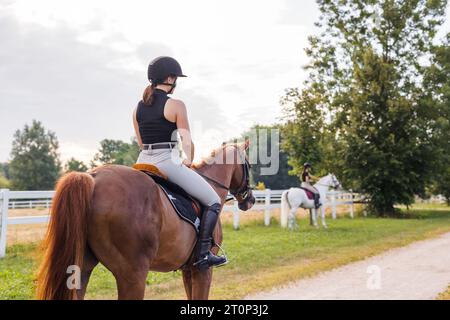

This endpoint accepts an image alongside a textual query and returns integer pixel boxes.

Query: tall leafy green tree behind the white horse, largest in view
[284,0,447,215]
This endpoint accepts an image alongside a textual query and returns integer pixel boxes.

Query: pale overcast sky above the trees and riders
[0,0,450,162]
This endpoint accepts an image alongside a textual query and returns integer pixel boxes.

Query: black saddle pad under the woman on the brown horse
[143,171,202,233]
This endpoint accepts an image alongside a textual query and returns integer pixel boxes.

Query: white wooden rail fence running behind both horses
[0,189,355,258]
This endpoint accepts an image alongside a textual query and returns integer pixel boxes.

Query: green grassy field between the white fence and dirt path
[0,205,450,299]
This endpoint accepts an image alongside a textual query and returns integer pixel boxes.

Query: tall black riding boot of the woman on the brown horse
[194,203,228,271]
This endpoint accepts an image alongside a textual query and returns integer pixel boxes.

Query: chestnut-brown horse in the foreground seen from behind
[37,142,255,299]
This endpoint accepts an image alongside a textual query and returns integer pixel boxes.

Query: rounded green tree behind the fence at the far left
[9,120,61,190]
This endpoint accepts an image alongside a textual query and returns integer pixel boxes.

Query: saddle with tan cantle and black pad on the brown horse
[133,163,203,233]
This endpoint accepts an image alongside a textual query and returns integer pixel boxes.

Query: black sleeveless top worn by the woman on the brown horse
[136,89,177,144]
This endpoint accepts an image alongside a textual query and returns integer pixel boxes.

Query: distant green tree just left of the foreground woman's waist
[91,138,140,167]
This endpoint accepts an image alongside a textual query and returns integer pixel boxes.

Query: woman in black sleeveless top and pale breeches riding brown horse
[133,57,228,270]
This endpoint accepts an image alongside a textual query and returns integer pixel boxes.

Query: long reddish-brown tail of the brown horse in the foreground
[36,172,95,300]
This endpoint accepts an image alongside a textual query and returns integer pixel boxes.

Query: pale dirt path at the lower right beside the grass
[247,233,450,300]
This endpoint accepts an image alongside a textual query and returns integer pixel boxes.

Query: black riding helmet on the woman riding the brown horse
[147,56,186,85]
